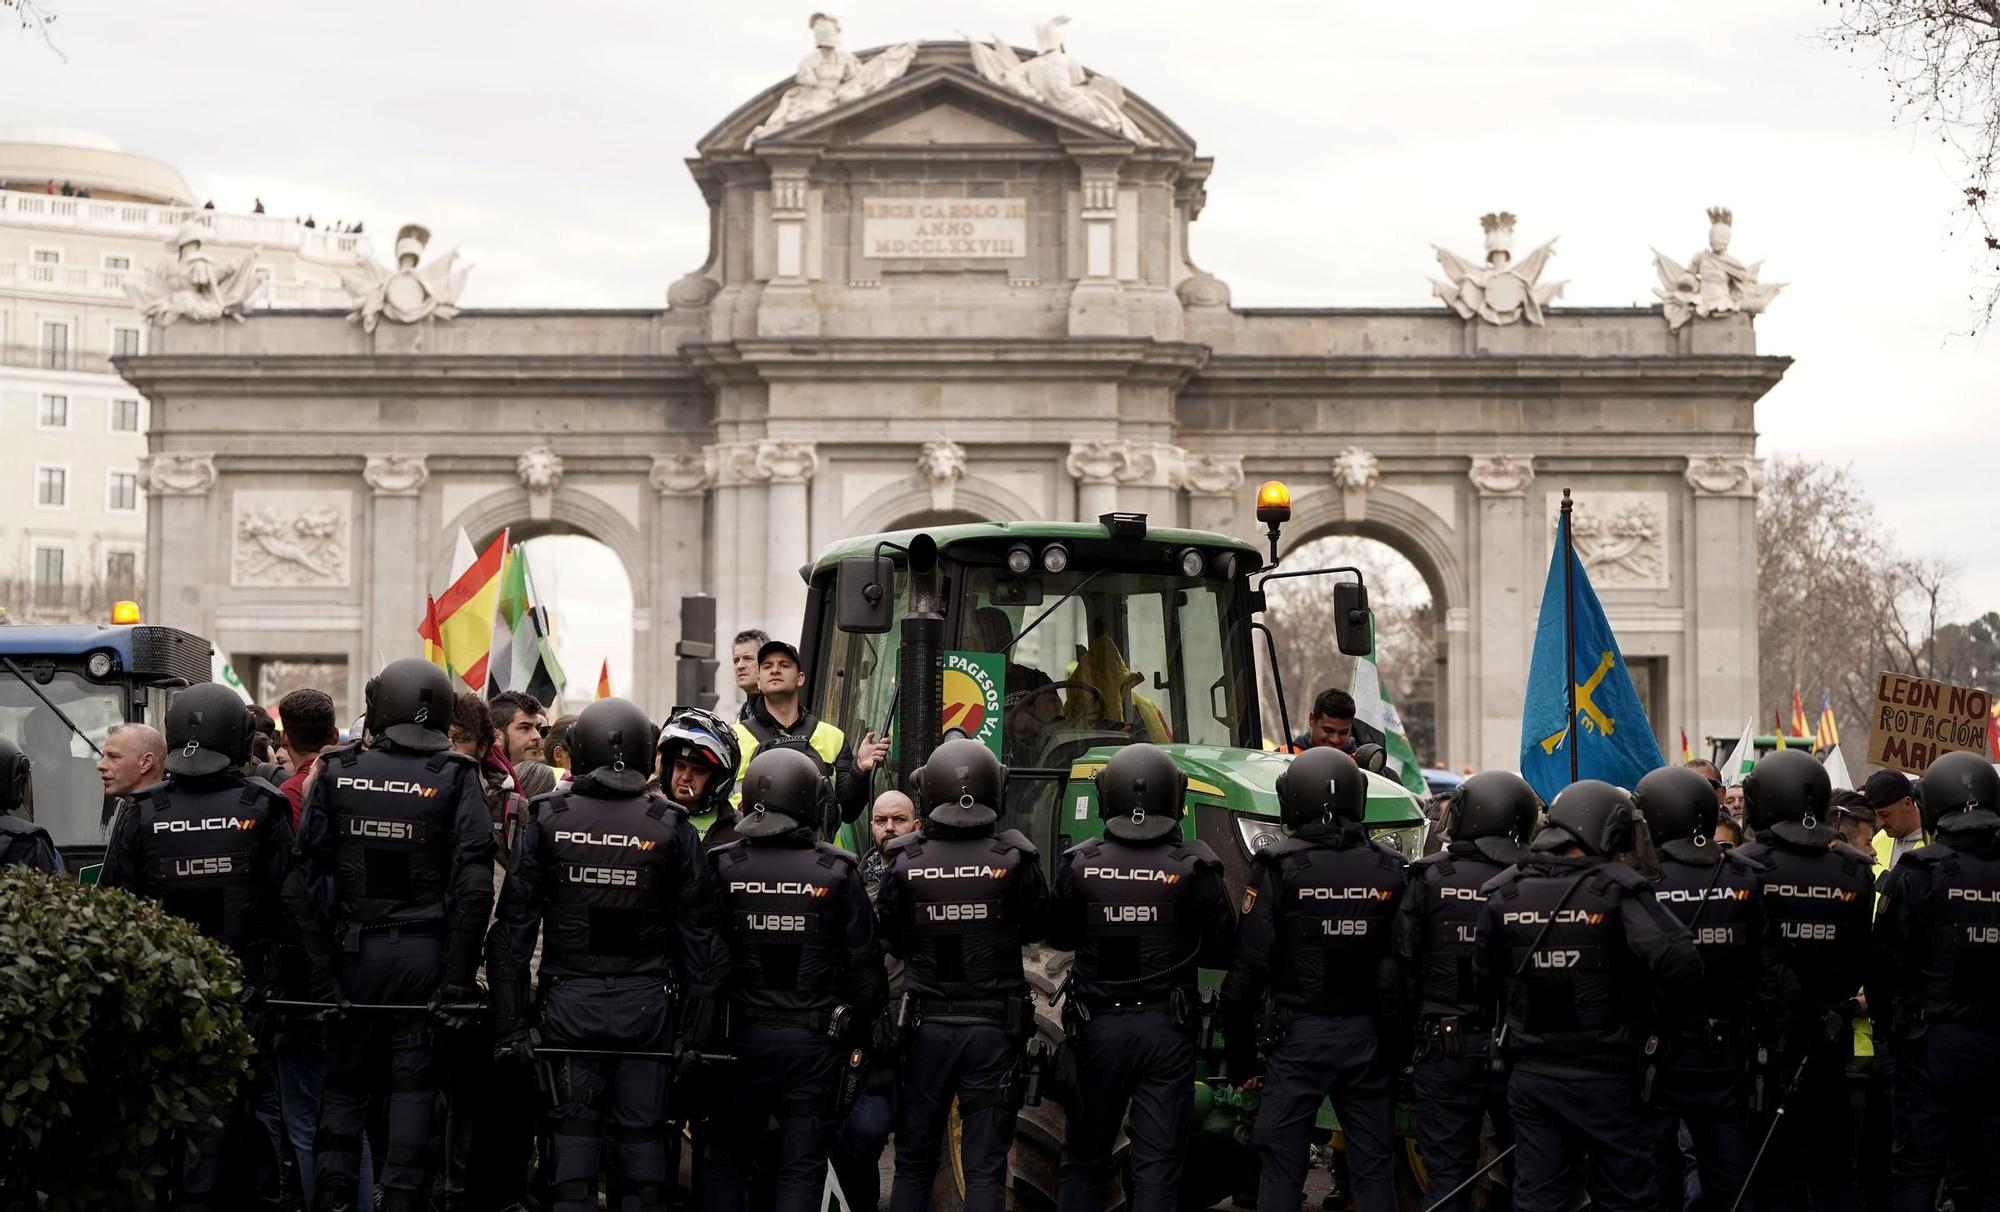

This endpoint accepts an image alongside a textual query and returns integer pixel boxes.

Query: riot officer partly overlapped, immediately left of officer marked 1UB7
[1396,770,1542,1212]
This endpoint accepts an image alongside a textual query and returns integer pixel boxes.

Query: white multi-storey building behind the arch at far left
[0,126,370,622]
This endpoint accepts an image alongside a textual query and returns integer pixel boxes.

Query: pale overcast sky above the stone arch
[0,0,2000,700]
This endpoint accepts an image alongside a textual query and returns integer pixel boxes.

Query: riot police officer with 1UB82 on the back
[1738,750,1874,1212]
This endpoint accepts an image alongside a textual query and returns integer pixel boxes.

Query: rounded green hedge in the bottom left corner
[0,866,252,1210]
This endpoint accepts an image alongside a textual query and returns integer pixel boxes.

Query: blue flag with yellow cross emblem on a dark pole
[1520,514,1666,800]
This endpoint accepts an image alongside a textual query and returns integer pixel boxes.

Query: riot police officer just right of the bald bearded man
[876,738,1048,1212]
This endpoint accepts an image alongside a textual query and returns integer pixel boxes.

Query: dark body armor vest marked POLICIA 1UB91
[1064,838,1222,1002]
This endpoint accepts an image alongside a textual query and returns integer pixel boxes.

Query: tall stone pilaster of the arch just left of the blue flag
[1450,454,1540,770]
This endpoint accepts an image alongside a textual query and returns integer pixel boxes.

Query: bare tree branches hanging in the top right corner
[1826,0,2000,326]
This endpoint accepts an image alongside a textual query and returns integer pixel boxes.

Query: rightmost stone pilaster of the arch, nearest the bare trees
[1670,454,1764,736]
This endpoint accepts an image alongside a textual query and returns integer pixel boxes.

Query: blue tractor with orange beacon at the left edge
[0,616,212,872]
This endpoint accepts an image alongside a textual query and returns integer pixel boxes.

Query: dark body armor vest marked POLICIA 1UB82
[1736,842,1874,1014]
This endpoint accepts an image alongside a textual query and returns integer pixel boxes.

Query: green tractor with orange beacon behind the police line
[800,496,1428,1208]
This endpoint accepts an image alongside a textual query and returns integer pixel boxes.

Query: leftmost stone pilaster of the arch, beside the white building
[144,450,219,636]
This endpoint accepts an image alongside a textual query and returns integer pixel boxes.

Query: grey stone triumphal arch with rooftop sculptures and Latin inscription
[120,28,1786,764]
